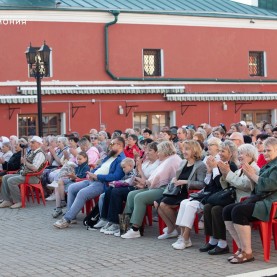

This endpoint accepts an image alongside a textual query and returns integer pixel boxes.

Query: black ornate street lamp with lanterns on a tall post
[25,42,51,137]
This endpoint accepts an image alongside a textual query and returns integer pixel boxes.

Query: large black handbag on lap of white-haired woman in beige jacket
[207,186,236,207]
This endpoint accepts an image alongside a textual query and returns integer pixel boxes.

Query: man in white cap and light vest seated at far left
[0,136,46,209]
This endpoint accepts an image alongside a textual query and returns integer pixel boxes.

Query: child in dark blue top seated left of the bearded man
[52,151,90,218]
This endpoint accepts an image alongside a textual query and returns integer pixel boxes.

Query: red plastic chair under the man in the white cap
[20,162,48,208]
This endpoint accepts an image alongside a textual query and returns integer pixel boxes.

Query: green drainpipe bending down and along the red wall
[104,10,277,83]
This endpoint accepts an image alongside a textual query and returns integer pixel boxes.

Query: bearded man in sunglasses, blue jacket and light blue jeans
[54,137,125,229]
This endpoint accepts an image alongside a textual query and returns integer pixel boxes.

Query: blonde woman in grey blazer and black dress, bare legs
[154,140,207,239]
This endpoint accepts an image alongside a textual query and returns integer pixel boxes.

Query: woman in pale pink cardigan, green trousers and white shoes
[121,141,182,239]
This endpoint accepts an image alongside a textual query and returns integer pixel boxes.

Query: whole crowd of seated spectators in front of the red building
[0,121,277,264]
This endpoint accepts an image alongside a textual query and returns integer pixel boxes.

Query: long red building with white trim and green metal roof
[0,0,277,135]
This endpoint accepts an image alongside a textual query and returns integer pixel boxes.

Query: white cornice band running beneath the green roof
[0,10,277,30]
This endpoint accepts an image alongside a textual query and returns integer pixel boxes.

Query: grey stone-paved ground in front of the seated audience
[0,202,277,277]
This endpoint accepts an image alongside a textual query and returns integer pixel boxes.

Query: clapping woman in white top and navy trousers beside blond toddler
[94,142,159,236]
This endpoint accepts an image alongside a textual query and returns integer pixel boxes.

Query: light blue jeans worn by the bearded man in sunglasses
[64,180,105,221]
